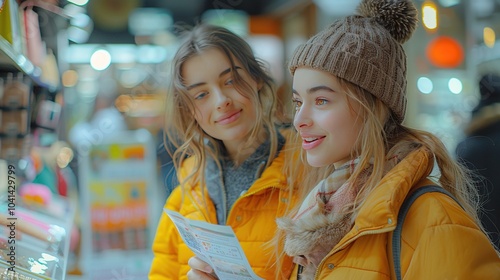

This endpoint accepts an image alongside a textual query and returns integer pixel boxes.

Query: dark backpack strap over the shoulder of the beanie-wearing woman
[392,185,460,280]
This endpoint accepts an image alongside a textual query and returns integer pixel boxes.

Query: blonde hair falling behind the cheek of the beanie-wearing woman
[339,79,481,221]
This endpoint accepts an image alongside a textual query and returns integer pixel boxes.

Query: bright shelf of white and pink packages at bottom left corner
[0,191,74,280]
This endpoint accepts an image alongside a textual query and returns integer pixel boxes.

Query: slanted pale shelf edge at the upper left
[0,36,56,91]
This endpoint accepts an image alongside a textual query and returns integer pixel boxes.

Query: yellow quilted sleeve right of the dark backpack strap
[401,194,500,280]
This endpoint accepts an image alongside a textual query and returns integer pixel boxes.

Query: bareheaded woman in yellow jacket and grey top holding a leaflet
[149,25,293,279]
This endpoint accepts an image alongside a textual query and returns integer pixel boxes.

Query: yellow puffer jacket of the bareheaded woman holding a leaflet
[149,144,296,280]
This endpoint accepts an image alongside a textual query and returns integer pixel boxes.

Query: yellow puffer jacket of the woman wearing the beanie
[310,149,500,280]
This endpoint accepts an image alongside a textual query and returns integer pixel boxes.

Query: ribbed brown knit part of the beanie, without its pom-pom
[289,15,407,122]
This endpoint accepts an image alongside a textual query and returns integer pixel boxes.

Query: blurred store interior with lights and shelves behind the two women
[0,0,500,279]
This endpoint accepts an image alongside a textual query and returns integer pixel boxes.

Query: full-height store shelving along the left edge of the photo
[0,0,74,280]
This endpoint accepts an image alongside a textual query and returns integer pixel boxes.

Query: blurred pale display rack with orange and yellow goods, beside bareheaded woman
[78,129,161,280]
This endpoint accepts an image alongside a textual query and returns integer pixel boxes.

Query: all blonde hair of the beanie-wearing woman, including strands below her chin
[272,75,483,278]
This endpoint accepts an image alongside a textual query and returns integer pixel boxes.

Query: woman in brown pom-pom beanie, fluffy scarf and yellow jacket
[278,0,500,280]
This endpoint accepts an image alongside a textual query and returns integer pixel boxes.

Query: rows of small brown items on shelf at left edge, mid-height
[0,72,31,159]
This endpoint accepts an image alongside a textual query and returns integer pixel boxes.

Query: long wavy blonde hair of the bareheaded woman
[164,24,278,189]
